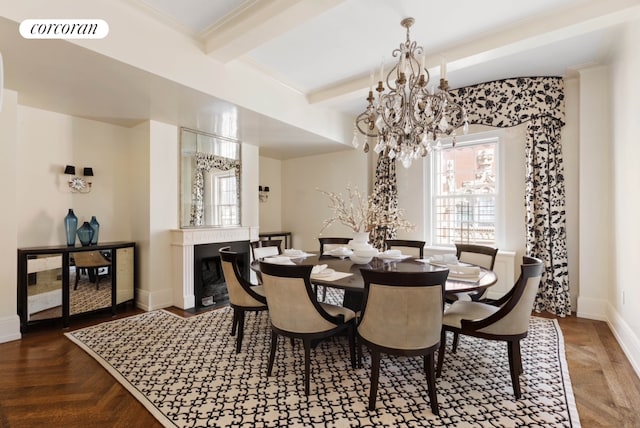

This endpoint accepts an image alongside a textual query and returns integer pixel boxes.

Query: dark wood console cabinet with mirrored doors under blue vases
[18,242,135,333]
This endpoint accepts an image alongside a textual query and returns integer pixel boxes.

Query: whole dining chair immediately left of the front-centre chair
[260,262,356,396]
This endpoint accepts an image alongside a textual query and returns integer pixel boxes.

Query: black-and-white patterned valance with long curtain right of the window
[451,77,571,317]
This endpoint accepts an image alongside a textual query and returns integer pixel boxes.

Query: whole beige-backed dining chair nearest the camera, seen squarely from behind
[358,269,449,415]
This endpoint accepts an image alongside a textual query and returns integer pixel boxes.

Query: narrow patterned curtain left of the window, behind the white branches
[369,155,398,251]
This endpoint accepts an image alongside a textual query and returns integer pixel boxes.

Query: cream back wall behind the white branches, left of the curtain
[282,150,371,251]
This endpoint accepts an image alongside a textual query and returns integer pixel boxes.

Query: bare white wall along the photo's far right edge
[608,21,640,376]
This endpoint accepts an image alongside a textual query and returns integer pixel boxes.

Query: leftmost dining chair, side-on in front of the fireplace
[218,247,267,354]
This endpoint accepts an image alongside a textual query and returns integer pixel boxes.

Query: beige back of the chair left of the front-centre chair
[260,262,338,333]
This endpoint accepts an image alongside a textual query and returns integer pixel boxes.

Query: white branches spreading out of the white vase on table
[316,186,415,233]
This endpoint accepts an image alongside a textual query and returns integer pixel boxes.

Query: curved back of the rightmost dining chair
[477,256,544,336]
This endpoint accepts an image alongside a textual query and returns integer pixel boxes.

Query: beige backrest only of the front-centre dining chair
[358,269,449,350]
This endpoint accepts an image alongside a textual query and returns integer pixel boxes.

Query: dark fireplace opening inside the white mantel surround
[193,241,250,311]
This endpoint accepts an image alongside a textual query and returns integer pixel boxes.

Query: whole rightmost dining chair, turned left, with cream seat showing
[438,256,544,399]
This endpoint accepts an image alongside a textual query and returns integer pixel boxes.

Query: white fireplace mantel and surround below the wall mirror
[171,227,258,309]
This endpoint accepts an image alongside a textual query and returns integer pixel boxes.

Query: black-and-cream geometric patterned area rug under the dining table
[66,294,580,427]
